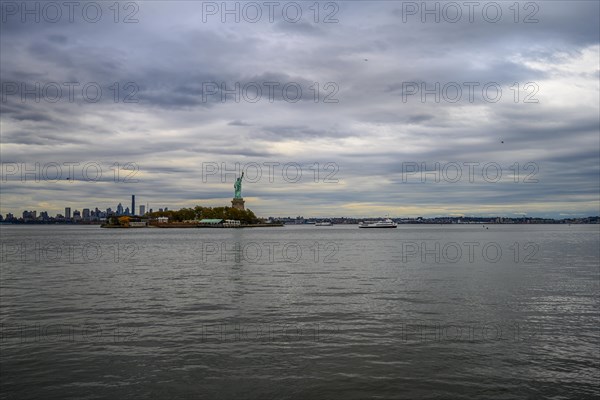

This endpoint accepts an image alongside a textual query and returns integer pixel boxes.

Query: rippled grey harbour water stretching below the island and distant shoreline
[0,225,600,399]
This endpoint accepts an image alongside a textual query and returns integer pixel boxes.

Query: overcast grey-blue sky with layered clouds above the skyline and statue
[0,1,600,218]
